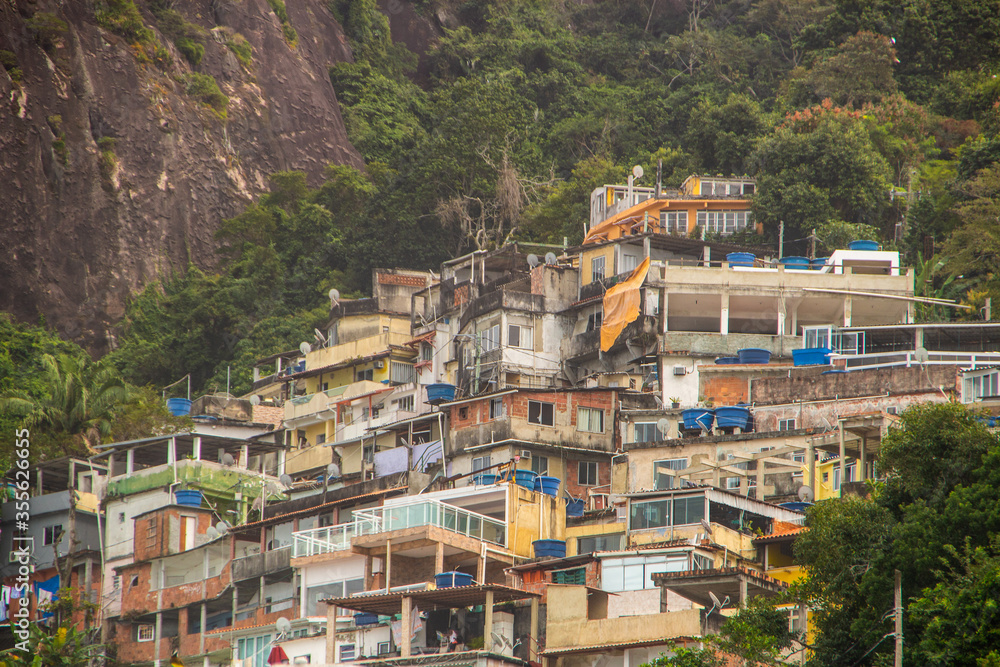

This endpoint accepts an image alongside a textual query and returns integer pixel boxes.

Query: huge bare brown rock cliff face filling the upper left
[0,0,361,352]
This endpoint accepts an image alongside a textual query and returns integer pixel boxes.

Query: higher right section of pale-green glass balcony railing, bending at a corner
[354,499,507,546]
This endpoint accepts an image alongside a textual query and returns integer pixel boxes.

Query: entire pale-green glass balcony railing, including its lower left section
[292,499,507,558]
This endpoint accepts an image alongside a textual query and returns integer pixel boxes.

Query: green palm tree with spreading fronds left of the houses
[0,354,132,451]
